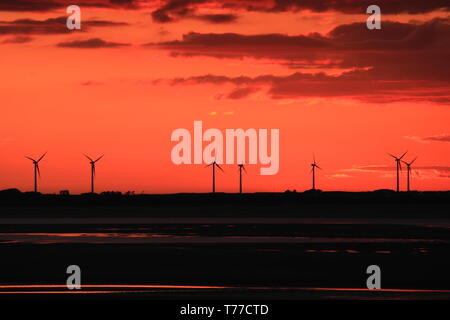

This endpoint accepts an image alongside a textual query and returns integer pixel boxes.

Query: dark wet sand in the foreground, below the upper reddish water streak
[0,229,450,299]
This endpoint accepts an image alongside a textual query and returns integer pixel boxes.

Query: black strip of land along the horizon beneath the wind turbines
[0,189,450,218]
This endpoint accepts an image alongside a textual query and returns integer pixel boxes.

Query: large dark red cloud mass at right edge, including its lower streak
[153,19,450,104]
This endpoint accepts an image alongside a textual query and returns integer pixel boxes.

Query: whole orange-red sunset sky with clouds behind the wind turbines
[0,0,450,193]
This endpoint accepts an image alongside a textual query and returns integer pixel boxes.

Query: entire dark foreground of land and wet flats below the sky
[0,190,450,299]
